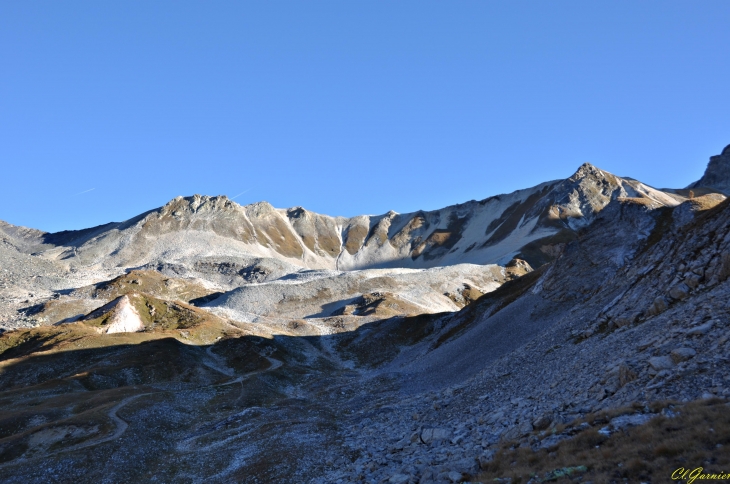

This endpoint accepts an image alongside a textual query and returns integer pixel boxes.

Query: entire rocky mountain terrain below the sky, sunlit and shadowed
[0,145,730,483]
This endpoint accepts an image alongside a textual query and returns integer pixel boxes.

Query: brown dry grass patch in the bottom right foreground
[473,399,730,484]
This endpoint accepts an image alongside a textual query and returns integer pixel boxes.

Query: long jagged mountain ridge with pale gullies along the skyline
[6,163,685,278]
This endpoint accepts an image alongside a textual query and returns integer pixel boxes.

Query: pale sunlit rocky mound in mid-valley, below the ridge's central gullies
[205,264,516,322]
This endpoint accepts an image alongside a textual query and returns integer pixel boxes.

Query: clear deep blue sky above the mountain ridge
[0,0,730,231]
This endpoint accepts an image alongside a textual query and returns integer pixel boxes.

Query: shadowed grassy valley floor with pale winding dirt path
[0,325,355,482]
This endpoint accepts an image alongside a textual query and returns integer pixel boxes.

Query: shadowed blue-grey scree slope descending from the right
[320,185,730,482]
